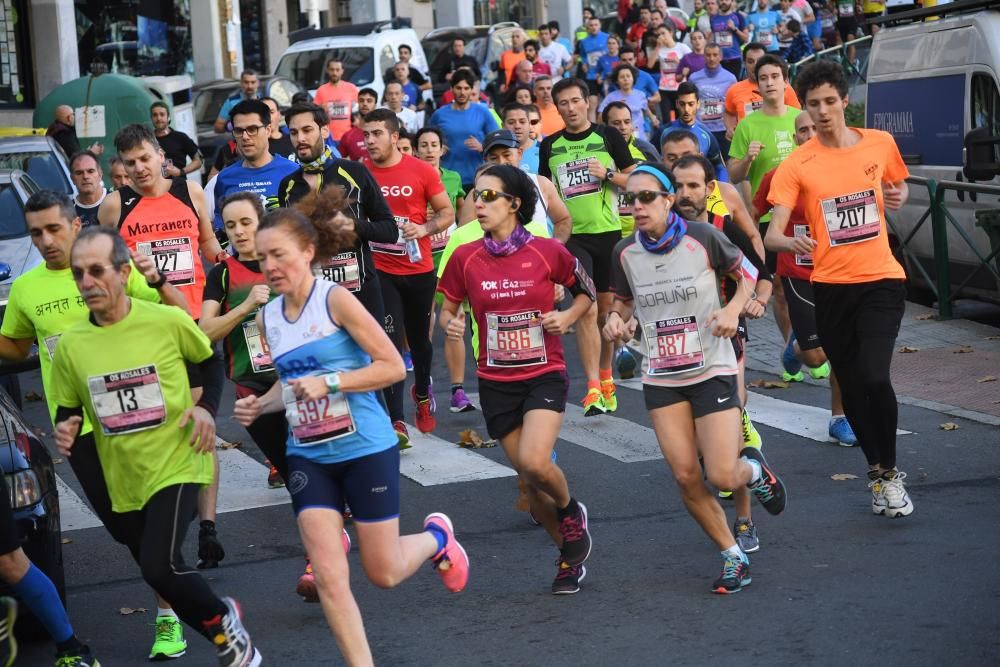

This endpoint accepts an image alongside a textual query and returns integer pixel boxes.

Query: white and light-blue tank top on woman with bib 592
[263,279,398,463]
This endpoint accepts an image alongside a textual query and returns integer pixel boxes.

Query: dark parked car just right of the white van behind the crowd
[420,21,521,100]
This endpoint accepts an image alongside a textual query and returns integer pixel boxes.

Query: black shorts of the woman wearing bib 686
[479,371,569,440]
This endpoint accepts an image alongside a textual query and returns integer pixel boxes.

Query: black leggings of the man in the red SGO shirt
[378,271,437,421]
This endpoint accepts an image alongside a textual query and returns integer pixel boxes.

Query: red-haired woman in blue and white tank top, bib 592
[233,204,469,665]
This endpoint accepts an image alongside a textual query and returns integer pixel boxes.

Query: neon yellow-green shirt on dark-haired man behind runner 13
[0,264,160,435]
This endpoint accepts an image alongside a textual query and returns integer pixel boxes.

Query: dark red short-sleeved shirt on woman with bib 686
[438,237,577,381]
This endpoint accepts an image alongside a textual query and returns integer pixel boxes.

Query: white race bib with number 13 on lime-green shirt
[87,366,167,435]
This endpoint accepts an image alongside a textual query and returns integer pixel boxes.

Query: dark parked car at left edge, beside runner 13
[0,378,66,640]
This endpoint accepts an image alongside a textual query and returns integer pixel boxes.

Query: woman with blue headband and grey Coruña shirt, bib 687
[604,163,785,593]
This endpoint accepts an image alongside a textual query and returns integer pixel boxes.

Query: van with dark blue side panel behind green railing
[865,0,1000,301]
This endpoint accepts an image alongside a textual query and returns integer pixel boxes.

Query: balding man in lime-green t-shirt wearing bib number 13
[52,226,261,667]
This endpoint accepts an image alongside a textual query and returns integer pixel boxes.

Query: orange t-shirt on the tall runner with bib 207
[768,128,910,284]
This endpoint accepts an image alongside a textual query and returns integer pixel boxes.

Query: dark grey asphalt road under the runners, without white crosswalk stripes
[18,332,1000,666]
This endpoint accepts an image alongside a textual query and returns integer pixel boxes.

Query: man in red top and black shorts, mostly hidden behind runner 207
[753,111,858,447]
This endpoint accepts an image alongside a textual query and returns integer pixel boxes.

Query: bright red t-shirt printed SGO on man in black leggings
[361,154,444,276]
